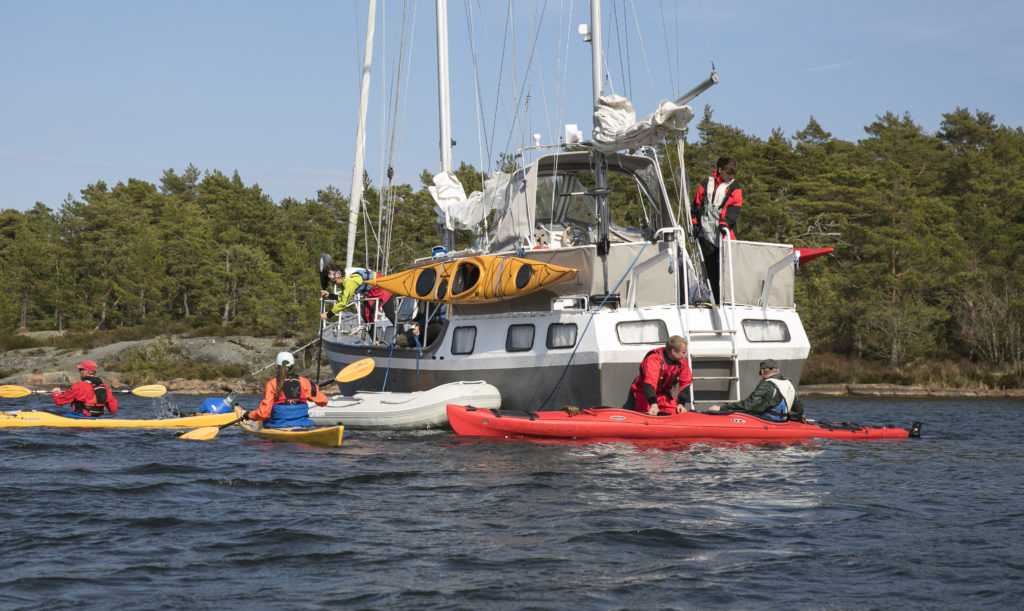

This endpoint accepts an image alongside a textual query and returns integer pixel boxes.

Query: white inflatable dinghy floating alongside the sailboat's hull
[309,381,502,430]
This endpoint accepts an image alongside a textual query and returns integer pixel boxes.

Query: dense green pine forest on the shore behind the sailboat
[0,107,1024,387]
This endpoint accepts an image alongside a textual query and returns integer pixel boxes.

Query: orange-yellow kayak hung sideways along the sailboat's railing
[367,255,577,304]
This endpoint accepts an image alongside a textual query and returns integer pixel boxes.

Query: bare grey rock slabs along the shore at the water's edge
[0,336,1024,398]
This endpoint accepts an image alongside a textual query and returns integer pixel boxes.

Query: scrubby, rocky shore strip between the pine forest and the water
[0,333,1024,398]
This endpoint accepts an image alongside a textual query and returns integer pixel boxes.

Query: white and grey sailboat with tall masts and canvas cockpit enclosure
[323,0,810,411]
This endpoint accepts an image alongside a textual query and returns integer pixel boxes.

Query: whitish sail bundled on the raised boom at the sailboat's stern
[594,94,693,152]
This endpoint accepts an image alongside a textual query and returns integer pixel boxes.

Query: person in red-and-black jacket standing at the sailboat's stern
[690,157,743,305]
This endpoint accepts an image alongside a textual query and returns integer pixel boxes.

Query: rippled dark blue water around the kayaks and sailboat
[0,396,1024,609]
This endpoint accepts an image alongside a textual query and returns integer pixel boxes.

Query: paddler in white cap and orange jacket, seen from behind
[241,352,327,429]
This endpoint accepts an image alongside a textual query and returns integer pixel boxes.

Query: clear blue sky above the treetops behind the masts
[0,0,1024,210]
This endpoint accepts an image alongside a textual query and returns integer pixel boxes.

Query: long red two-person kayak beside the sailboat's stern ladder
[447,404,921,441]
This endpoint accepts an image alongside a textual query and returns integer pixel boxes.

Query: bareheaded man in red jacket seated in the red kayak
[624,336,693,416]
